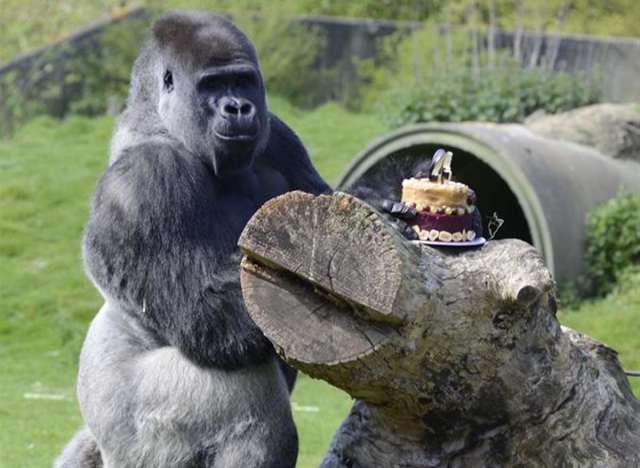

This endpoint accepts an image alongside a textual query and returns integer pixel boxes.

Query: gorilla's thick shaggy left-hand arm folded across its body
[83,144,273,368]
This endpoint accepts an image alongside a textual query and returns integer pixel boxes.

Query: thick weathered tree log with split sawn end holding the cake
[239,192,640,468]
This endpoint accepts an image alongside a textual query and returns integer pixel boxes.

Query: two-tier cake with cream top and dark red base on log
[402,149,482,243]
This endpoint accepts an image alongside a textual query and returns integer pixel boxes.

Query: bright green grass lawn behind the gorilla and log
[0,99,640,468]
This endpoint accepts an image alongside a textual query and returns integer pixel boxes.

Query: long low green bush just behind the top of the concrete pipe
[382,63,600,127]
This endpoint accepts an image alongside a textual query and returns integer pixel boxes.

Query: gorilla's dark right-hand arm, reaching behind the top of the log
[263,114,333,195]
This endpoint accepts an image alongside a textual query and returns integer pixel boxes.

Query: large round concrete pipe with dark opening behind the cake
[338,123,640,281]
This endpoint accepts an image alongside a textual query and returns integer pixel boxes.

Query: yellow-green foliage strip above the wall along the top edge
[5,0,640,63]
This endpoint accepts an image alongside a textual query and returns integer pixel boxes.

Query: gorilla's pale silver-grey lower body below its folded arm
[74,303,297,468]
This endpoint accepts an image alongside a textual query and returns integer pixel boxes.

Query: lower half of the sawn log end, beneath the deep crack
[241,258,393,369]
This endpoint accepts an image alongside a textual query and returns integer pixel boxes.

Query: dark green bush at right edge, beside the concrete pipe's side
[585,193,640,295]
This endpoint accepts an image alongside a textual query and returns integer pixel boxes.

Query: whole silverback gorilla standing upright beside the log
[56,12,330,468]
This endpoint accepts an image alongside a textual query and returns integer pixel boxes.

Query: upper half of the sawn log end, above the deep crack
[239,192,415,324]
